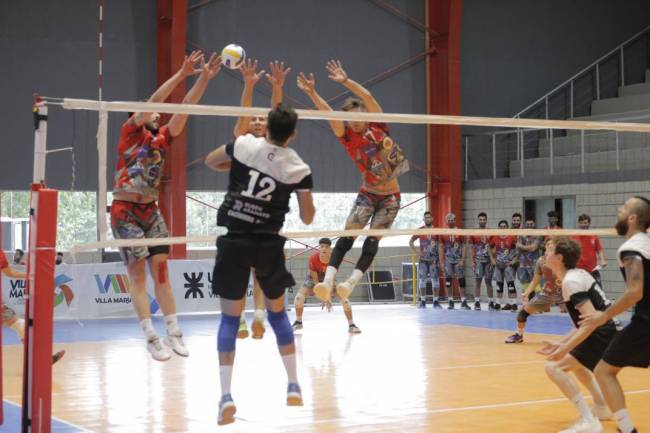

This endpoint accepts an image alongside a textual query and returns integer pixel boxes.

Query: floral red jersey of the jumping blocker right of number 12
[339,122,408,186]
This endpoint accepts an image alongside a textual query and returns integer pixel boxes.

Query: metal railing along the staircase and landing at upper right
[463,26,650,180]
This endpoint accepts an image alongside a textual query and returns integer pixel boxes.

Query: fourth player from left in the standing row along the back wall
[490,220,517,312]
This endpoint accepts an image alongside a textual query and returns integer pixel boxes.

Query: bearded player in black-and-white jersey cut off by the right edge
[581,196,650,433]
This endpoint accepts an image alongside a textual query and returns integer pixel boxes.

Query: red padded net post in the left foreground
[21,183,58,433]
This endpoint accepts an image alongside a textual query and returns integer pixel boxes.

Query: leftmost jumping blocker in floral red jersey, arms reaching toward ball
[111,51,221,361]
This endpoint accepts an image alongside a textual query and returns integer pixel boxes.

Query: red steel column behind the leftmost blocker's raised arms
[156,0,187,259]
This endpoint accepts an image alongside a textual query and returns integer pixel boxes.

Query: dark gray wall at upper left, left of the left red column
[0,0,156,190]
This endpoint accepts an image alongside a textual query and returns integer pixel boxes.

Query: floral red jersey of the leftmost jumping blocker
[113,117,172,198]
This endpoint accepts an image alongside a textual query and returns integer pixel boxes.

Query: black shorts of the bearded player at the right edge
[603,318,650,368]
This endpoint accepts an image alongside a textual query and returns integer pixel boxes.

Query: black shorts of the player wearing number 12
[212,233,296,300]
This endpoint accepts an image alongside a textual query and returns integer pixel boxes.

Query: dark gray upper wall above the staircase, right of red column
[461,0,650,117]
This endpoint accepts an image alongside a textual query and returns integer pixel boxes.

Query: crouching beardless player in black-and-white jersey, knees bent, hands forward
[539,237,616,433]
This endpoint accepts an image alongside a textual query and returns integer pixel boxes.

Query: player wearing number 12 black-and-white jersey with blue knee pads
[206,104,315,425]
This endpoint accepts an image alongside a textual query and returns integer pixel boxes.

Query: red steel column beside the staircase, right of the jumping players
[425,0,463,226]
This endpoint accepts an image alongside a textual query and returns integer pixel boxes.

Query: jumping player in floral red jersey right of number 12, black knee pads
[298,60,408,308]
